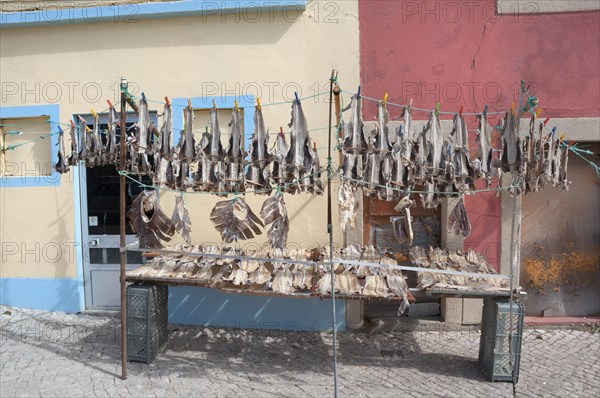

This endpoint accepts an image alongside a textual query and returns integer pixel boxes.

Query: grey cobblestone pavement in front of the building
[0,307,600,398]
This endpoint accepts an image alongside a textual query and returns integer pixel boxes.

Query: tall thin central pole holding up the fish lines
[327,70,337,398]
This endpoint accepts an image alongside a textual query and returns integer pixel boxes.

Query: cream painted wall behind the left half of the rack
[0,1,359,277]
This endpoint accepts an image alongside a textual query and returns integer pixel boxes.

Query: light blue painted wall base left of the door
[0,278,84,313]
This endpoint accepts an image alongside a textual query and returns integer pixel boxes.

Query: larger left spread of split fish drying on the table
[128,245,414,304]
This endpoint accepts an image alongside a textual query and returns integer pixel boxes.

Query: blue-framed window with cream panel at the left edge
[0,105,60,188]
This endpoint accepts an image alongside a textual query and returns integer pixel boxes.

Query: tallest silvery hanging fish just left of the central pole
[286,99,312,193]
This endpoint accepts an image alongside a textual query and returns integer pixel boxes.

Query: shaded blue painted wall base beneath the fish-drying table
[169,286,346,331]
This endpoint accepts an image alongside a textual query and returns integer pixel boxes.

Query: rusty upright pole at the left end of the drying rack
[119,77,128,380]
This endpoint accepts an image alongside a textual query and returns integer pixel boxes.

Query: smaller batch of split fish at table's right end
[409,246,508,290]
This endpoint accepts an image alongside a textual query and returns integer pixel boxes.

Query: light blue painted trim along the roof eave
[0,0,306,28]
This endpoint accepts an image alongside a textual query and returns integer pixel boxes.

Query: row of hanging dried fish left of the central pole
[55,96,324,196]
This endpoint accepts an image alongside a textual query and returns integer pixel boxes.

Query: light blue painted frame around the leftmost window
[0,105,60,188]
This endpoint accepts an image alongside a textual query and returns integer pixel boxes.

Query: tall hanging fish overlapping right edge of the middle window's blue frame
[246,104,271,194]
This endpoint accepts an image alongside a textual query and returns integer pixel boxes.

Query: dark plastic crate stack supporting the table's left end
[127,284,168,363]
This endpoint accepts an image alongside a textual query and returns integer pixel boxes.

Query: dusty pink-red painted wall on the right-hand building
[359,0,600,266]
